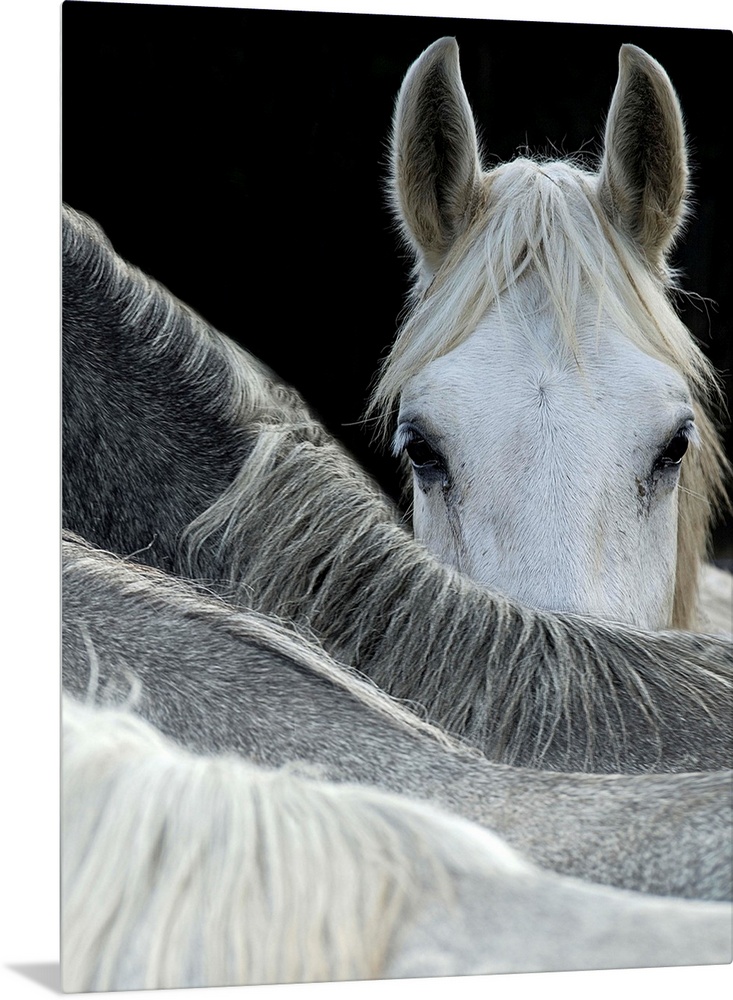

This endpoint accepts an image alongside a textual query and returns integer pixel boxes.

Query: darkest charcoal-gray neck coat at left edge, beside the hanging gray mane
[62,210,252,570]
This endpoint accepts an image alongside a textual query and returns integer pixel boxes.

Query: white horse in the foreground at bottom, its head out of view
[62,698,731,992]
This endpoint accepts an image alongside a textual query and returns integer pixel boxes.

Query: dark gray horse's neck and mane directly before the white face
[64,205,733,771]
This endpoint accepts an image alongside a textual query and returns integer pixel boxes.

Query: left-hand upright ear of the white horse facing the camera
[391,38,481,273]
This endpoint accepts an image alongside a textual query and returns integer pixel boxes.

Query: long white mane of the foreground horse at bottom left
[62,698,516,992]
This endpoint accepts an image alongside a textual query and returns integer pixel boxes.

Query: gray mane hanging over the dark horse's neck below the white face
[182,410,731,770]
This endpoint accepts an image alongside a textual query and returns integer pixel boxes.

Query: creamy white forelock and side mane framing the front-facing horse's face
[367,158,728,628]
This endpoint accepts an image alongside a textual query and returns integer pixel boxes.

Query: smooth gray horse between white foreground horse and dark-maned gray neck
[63,541,730,898]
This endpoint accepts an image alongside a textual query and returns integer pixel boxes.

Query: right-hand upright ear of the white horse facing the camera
[599,45,688,270]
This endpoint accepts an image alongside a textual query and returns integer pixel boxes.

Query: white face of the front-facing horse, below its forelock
[395,277,696,628]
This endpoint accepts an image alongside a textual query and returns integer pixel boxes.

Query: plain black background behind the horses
[62,0,733,558]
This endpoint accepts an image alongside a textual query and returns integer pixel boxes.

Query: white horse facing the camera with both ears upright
[371,38,733,630]
